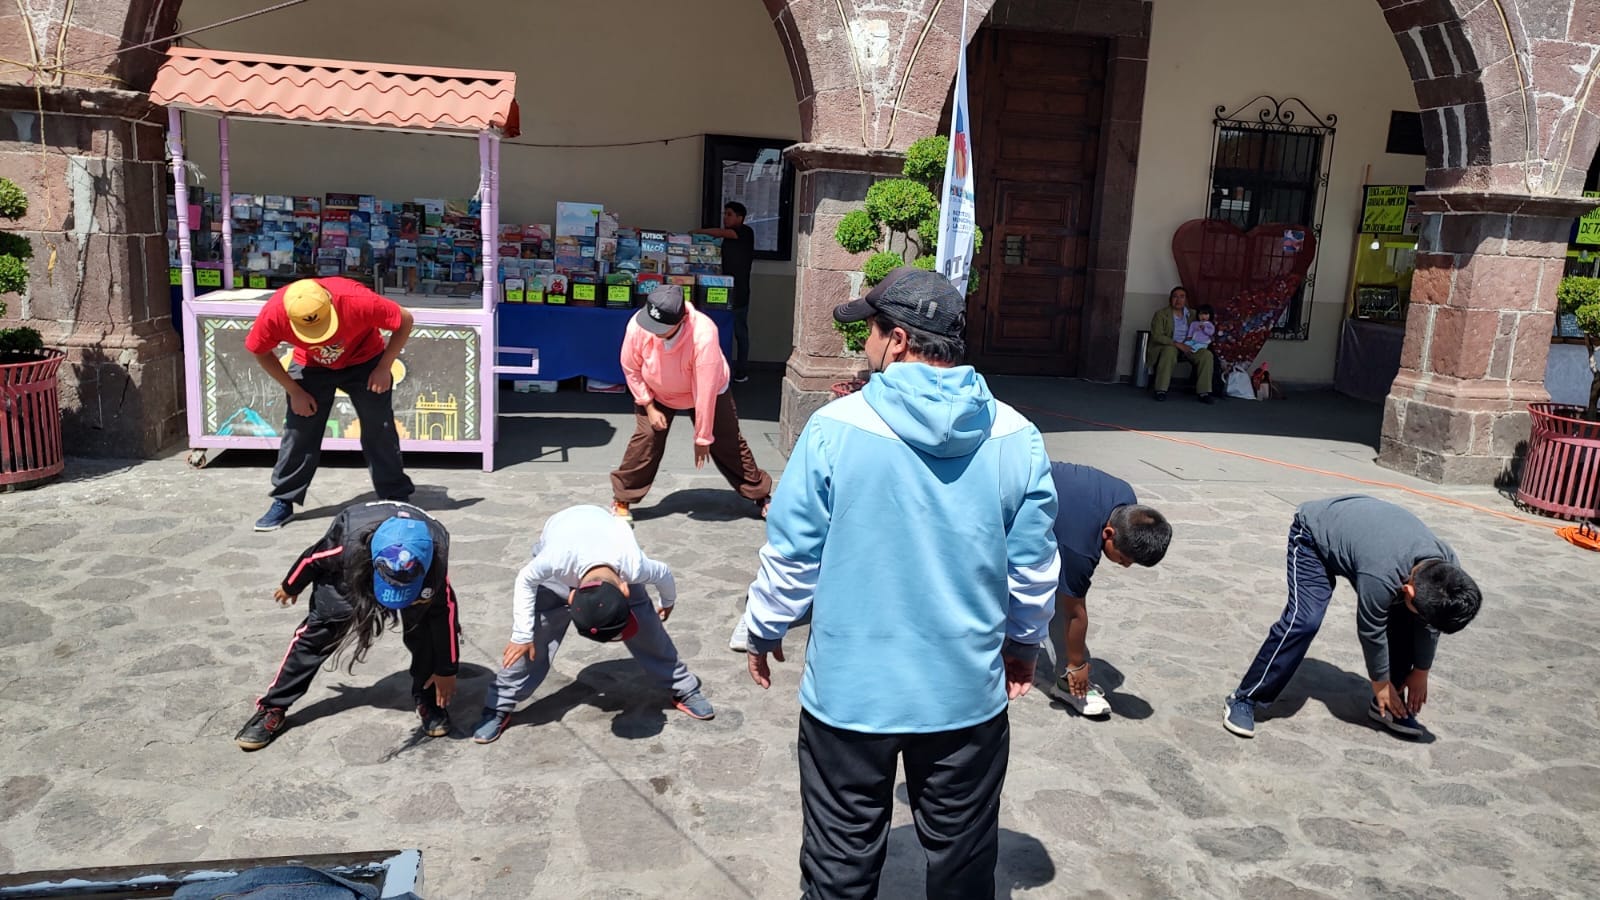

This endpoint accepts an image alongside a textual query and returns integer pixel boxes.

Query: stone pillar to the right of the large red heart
[1378,192,1594,484]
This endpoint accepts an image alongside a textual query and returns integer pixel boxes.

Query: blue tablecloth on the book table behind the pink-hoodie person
[499,303,733,384]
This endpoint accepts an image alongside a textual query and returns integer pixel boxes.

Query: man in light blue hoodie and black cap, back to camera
[744,267,1059,900]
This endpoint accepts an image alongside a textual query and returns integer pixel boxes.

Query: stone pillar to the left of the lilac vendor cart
[0,85,184,456]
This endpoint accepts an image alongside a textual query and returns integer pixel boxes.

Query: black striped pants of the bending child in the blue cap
[256,585,450,709]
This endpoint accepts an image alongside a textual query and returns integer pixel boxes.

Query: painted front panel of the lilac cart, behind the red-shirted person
[197,314,478,440]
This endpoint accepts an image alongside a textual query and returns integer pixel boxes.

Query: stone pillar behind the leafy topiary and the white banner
[779,144,906,453]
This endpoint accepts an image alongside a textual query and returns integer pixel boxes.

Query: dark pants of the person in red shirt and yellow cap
[272,357,416,503]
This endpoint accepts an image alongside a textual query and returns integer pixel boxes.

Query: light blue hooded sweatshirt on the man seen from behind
[746,362,1059,733]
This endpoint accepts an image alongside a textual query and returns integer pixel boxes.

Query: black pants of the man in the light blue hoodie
[800,711,1011,900]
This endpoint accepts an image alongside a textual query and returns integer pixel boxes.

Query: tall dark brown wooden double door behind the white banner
[966,29,1107,375]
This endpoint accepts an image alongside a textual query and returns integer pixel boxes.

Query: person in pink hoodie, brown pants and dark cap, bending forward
[611,285,773,520]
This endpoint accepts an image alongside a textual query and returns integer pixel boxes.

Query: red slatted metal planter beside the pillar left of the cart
[0,349,66,487]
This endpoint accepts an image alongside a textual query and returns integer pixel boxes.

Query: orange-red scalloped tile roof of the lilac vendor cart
[150,46,520,138]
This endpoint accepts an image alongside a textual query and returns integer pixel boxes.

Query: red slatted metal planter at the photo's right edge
[1517,404,1600,519]
